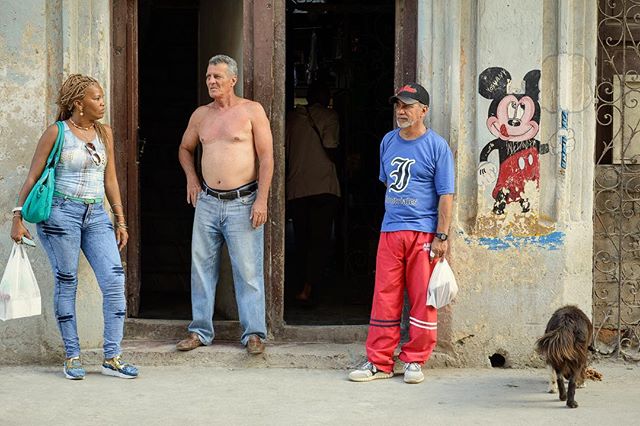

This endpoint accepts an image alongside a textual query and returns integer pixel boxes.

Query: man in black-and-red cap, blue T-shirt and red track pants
[349,83,454,383]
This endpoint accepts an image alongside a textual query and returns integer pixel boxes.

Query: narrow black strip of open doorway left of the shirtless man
[138,0,198,319]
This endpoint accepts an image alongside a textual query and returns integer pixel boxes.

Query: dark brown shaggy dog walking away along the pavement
[536,306,593,408]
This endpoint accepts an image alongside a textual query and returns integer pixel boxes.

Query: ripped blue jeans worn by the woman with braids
[37,196,126,358]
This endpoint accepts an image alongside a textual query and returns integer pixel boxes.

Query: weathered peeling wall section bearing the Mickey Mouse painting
[418,0,597,366]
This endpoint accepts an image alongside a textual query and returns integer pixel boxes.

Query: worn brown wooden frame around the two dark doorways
[111,0,418,342]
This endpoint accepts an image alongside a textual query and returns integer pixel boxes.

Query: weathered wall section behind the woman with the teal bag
[0,0,110,363]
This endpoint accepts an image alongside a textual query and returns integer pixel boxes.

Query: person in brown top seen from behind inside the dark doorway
[285,81,340,304]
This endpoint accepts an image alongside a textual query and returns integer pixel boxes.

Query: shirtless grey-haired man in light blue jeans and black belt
[176,55,273,354]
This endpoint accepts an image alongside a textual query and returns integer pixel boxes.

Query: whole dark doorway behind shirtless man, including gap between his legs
[137,0,243,320]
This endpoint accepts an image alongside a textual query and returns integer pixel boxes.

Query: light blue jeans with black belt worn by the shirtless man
[189,192,267,345]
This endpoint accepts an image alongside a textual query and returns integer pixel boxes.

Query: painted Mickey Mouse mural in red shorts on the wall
[478,67,549,215]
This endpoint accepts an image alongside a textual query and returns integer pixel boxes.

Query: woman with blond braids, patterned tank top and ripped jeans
[11,74,138,380]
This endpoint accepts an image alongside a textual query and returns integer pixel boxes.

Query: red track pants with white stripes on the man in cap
[367,231,438,372]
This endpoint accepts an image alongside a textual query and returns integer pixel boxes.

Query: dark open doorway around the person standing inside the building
[284,0,395,325]
